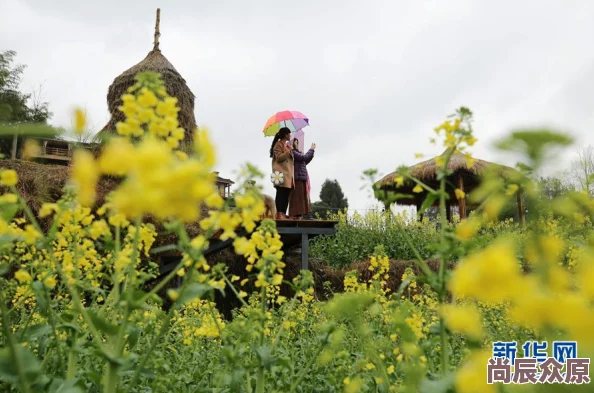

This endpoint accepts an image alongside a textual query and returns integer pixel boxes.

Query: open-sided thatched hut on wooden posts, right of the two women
[374,150,524,223]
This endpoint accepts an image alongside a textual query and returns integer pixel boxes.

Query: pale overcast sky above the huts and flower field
[0,0,594,210]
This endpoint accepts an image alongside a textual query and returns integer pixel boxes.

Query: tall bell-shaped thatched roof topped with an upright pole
[98,9,196,147]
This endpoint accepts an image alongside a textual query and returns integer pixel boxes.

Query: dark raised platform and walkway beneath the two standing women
[155,220,338,274]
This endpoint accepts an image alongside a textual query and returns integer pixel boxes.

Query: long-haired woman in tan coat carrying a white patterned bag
[270,127,295,220]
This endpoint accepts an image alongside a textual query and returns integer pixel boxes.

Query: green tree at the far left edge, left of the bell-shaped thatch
[0,50,59,154]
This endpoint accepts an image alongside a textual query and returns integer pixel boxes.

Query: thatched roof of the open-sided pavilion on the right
[374,150,518,205]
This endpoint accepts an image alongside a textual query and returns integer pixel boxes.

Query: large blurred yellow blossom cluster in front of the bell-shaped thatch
[65,74,223,222]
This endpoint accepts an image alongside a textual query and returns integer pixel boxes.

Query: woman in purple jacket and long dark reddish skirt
[289,138,316,219]
